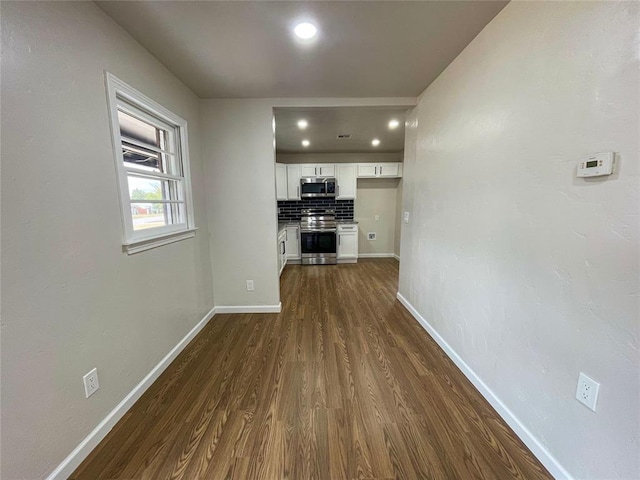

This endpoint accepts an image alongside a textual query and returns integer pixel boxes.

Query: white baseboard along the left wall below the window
[47,307,216,480]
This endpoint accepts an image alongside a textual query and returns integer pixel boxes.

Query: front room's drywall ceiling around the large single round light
[96,1,508,98]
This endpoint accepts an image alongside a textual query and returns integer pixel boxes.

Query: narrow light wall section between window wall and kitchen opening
[201,99,280,306]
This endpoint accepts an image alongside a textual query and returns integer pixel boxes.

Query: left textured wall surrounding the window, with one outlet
[1,2,213,480]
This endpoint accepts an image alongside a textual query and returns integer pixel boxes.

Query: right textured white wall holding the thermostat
[399,2,640,479]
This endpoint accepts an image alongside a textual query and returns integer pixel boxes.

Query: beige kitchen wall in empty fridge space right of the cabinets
[354,178,400,255]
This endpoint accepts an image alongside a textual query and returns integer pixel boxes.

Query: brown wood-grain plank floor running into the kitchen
[71,259,551,480]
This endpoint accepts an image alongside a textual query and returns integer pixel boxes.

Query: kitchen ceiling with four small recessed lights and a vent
[275,107,407,153]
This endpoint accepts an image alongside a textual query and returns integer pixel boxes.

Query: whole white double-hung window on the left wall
[106,73,196,254]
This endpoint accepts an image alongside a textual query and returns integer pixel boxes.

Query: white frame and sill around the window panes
[105,72,197,255]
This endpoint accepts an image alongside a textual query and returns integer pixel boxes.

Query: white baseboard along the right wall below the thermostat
[396,292,573,480]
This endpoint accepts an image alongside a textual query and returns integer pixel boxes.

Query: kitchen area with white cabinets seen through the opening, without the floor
[274,107,404,274]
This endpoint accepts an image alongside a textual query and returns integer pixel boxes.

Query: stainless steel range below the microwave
[300,208,338,265]
